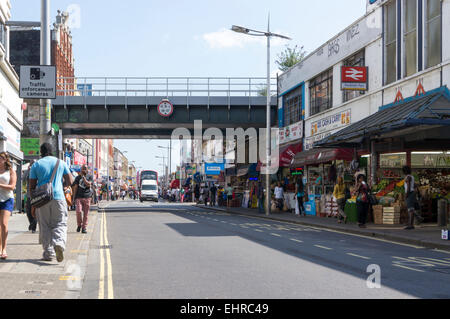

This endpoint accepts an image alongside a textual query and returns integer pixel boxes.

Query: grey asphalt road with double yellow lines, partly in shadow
[81,200,450,299]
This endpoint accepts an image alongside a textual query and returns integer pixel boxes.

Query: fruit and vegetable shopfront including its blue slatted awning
[317,87,450,224]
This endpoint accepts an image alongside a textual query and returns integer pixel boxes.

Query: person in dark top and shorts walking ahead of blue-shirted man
[72,165,93,234]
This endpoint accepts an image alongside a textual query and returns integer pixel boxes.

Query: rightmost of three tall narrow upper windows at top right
[425,0,442,68]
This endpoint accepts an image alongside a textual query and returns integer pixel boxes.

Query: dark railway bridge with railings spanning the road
[52,77,277,139]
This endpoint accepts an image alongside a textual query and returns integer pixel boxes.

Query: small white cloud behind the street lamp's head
[200,29,287,49]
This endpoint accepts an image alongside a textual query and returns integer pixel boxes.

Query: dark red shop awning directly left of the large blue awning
[291,148,354,167]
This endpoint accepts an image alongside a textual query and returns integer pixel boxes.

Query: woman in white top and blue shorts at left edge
[0,152,17,260]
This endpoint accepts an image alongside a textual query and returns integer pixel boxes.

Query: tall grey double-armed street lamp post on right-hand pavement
[231,17,291,215]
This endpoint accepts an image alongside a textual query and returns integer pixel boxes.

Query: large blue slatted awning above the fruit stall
[314,87,450,147]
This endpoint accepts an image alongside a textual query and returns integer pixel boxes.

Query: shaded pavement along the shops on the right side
[196,205,450,251]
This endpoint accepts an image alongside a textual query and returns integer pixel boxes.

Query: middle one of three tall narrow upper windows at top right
[403,0,417,76]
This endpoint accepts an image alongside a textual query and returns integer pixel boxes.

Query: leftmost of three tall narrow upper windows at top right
[384,1,397,84]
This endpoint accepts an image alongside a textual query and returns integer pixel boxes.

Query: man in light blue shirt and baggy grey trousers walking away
[30,143,73,262]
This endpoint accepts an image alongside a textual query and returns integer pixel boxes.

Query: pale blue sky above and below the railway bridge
[11,0,366,178]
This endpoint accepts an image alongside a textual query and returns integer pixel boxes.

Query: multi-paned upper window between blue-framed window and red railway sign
[309,69,333,115]
